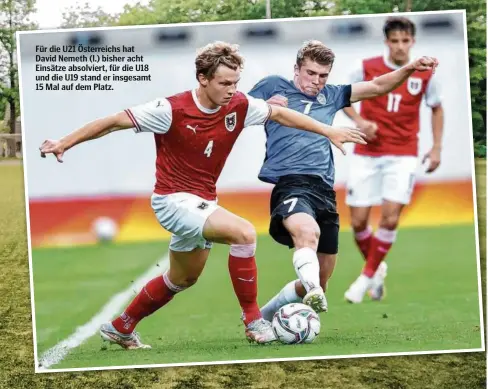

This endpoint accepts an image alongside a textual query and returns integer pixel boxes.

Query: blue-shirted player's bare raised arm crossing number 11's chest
[351,57,439,103]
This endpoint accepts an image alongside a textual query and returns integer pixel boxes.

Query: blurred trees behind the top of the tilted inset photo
[0,0,486,157]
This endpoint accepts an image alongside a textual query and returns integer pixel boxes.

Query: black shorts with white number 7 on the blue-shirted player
[269,174,339,254]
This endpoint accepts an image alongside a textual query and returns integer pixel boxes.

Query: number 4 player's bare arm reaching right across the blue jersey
[269,105,366,155]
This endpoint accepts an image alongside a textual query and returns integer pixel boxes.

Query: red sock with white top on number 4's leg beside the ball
[229,244,261,326]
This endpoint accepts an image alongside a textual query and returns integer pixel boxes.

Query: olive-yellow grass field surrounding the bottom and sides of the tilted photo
[0,161,486,389]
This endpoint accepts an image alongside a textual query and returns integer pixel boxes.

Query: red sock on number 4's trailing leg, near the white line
[112,273,185,334]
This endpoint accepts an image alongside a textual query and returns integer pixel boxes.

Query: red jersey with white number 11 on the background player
[354,56,440,156]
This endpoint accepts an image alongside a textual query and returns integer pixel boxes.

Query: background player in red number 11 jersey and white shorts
[344,17,444,303]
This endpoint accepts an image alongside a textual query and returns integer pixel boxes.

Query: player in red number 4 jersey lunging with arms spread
[40,42,365,349]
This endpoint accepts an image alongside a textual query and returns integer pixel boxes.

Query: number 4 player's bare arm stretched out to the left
[39,112,134,162]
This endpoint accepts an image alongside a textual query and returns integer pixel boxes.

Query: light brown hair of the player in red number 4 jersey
[195,42,244,80]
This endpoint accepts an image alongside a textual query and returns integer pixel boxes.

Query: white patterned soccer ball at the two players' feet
[271,303,320,344]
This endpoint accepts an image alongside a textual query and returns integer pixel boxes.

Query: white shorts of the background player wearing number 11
[346,154,418,207]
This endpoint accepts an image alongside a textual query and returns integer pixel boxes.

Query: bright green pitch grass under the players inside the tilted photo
[33,226,481,368]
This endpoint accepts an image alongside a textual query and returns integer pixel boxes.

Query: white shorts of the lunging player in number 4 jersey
[151,192,219,251]
